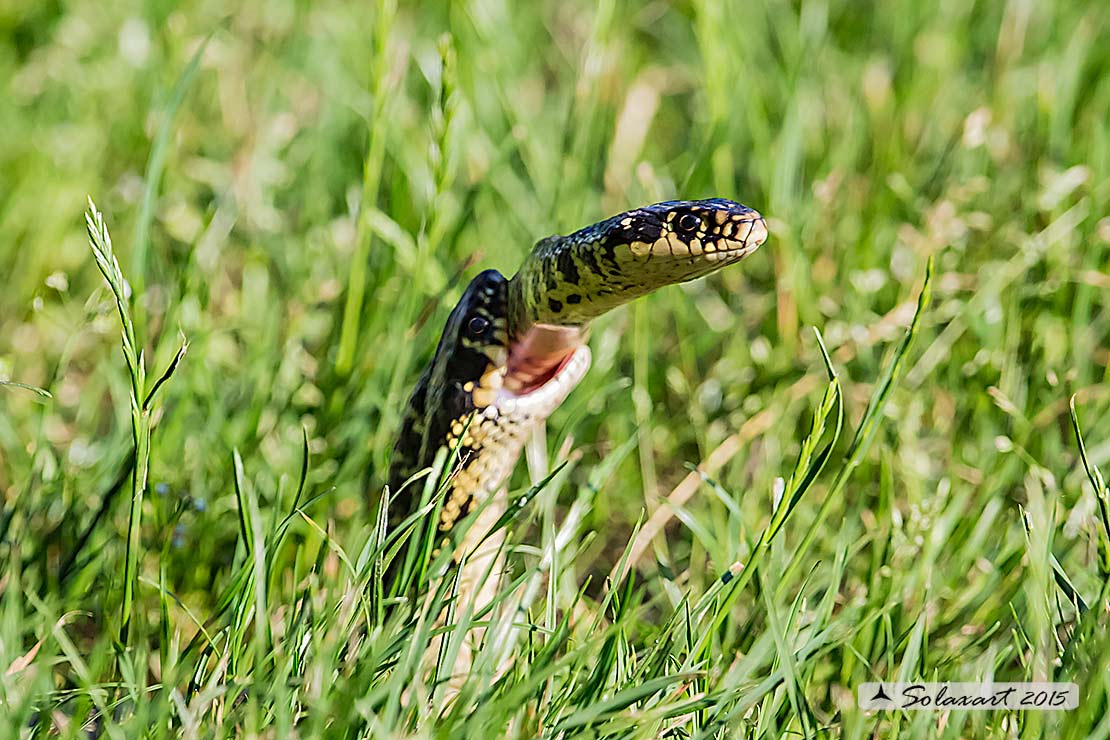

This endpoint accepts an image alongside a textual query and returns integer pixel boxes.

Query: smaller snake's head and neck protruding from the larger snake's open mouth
[509,197,767,333]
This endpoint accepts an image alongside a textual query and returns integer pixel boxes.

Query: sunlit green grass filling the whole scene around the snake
[0,0,1110,738]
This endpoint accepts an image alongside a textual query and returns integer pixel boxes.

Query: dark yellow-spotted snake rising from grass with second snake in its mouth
[387,197,768,588]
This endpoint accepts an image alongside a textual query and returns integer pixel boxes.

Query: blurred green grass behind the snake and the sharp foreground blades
[0,0,1110,737]
